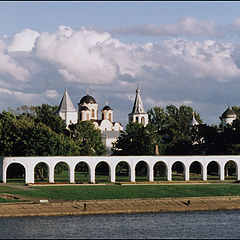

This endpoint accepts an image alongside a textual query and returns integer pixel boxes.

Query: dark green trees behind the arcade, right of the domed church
[113,105,240,155]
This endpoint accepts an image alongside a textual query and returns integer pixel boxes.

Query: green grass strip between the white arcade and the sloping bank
[0,184,240,200]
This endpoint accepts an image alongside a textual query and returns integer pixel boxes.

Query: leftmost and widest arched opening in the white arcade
[7,163,26,183]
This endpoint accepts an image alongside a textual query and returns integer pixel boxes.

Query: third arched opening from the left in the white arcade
[54,162,70,183]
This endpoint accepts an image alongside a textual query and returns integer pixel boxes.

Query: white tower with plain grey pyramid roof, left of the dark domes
[57,89,78,126]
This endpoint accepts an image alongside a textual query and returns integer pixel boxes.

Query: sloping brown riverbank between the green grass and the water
[0,196,240,217]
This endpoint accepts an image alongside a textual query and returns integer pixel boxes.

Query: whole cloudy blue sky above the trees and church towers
[0,1,240,126]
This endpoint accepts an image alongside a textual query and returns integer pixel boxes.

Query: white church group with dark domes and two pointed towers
[58,87,148,154]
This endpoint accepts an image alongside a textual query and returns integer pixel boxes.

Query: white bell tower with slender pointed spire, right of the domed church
[128,85,148,127]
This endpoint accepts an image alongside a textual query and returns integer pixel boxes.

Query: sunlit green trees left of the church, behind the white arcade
[0,104,106,156]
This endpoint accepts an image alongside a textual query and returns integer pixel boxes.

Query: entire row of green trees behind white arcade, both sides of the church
[0,104,240,156]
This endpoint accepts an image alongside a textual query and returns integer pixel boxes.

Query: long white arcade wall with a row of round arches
[0,155,240,183]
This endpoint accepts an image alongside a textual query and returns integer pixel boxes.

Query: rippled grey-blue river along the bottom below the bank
[0,210,240,239]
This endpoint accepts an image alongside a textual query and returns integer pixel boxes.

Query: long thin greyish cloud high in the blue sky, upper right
[112,17,222,37]
